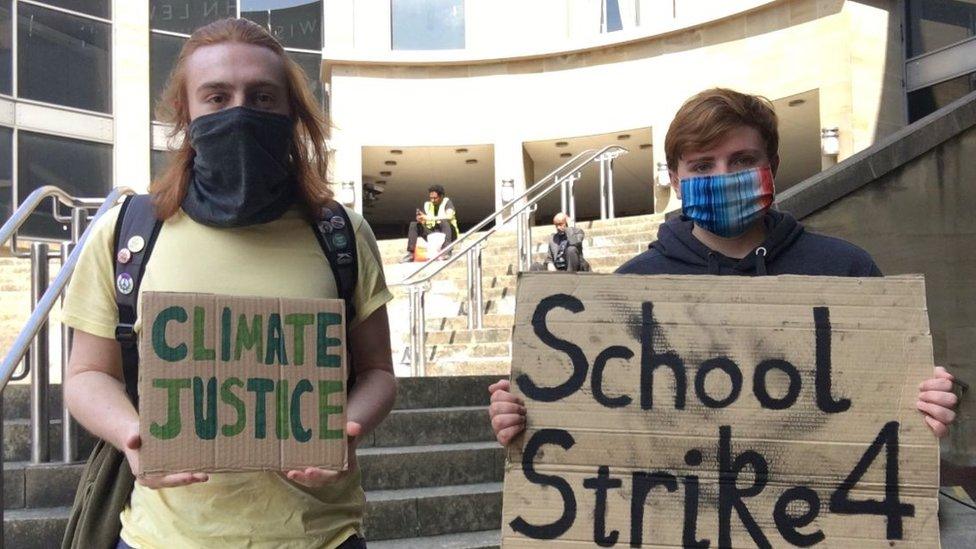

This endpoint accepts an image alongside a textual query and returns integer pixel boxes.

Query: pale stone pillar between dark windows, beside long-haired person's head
[112,0,152,192]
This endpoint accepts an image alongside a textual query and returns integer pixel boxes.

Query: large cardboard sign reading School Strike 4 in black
[502,273,939,547]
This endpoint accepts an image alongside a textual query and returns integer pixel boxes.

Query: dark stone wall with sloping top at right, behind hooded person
[780,94,976,466]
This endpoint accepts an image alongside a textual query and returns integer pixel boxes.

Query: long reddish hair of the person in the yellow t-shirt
[149,18,332,220]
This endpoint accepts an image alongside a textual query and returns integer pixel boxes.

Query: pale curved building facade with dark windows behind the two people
[0,0,976,234]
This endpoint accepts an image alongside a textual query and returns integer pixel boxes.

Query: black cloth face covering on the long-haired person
[183,107,297,227]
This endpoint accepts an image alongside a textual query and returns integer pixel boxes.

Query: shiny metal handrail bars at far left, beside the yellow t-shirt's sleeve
[0,186,135,391]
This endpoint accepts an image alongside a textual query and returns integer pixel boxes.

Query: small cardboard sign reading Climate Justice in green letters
[139,292,347,474]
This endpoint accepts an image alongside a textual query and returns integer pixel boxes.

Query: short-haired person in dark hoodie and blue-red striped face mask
[488,88,957,446]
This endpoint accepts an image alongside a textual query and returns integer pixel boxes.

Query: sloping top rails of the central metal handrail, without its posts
[390,145,628,287]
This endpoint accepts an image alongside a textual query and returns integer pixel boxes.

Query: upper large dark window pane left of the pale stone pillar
[17,3,112,113]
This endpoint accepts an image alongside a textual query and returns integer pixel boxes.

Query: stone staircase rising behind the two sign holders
[0,212,661,549]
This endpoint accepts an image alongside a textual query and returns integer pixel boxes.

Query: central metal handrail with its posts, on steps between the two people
[390,145,628,375]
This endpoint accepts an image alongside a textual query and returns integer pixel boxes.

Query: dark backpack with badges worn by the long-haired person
[61,194,359,549]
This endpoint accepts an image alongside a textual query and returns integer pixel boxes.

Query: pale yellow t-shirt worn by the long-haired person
[62,203,393,548]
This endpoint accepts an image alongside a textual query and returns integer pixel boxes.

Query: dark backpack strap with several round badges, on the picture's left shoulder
[113,194,163,408]
